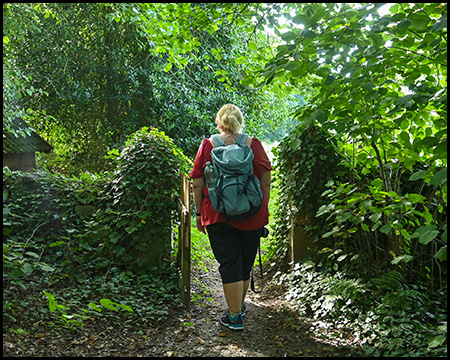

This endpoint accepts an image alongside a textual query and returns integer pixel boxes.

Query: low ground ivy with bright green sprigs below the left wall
[3,262,181,333]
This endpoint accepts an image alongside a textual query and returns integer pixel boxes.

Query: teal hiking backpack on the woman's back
[205,134,263,220]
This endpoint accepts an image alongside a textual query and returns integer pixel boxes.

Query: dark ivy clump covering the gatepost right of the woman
[273,127,345,268]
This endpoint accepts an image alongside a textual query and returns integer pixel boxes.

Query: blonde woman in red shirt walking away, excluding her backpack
[190,104,272,330]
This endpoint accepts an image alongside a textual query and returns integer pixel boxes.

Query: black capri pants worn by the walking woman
[206,222,262,284]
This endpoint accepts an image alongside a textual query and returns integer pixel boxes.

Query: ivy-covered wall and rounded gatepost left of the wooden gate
[3,128,187,276]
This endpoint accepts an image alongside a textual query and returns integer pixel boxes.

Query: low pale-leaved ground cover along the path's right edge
[278,261,447,356]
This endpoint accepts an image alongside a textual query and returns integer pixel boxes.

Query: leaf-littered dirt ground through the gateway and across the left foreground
[3,256,361,357]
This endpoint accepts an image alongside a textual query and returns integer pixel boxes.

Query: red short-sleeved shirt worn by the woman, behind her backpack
[189,138,272,230]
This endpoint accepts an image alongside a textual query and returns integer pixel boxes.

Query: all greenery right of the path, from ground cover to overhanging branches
[262,4,447,356]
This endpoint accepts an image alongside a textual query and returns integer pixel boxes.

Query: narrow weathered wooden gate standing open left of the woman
[177,174,191,310]
